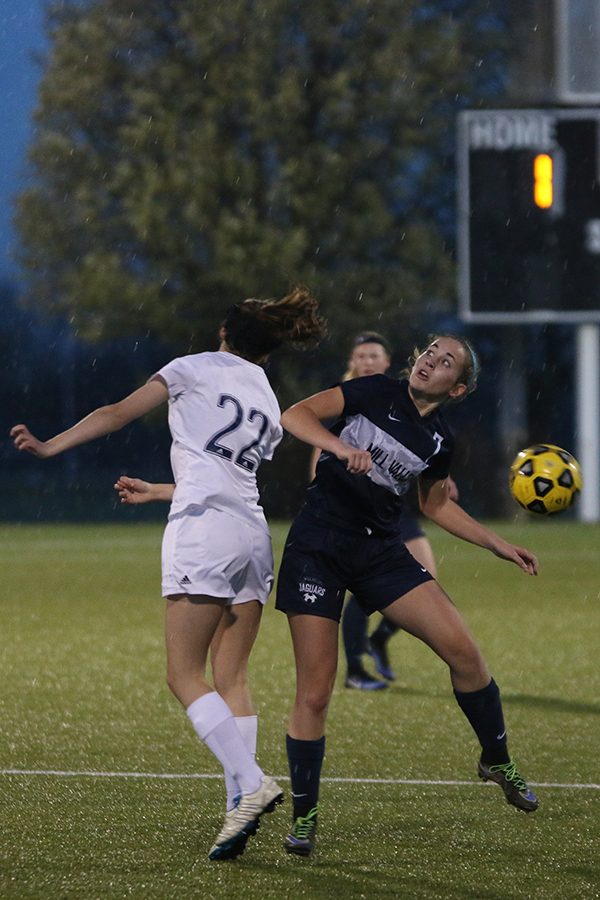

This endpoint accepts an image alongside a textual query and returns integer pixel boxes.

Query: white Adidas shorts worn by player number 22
[162,509,273,605]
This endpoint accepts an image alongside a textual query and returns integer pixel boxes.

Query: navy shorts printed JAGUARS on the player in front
[275,513,433,622]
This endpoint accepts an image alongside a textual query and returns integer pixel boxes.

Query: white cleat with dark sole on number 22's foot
[208,775,283,859]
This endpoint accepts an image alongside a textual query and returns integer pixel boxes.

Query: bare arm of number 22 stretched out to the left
[10,378,168,459]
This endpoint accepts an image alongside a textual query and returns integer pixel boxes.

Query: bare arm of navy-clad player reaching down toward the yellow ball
[419,479,538,575]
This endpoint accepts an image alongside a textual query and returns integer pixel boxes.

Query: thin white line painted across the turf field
[0,769,600,791]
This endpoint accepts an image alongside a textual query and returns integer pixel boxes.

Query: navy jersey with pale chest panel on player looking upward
[306,375,454,534]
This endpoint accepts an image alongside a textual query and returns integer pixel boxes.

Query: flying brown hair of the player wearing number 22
[223,285,327,361]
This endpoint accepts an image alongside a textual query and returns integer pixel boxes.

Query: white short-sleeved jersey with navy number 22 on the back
[157,351,283,528]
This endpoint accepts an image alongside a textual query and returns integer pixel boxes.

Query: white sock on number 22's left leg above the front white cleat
[186,691,263,794]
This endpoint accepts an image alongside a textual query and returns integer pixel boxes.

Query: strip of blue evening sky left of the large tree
[0,0,44,278]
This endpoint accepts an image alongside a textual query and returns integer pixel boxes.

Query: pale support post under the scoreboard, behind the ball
[575,324,600,522]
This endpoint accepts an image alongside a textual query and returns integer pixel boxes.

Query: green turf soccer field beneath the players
[0,519,600,900]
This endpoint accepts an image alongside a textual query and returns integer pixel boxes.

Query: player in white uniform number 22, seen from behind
[11,288,324,859]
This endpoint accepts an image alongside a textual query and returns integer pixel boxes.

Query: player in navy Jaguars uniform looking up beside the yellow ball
[277,335,538,855]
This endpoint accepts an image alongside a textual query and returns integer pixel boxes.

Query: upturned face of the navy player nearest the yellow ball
[409,337,466,402]
